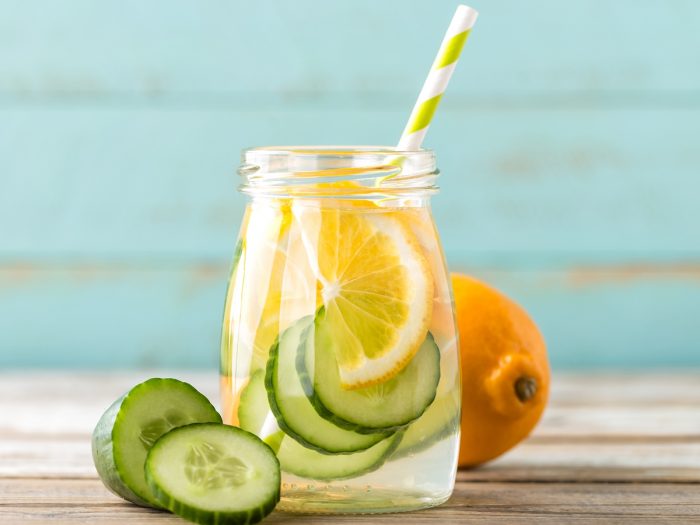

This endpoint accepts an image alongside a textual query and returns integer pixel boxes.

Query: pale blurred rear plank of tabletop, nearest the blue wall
[0,370,700,441]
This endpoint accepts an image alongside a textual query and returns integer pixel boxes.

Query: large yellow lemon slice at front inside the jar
[293,205,433,389]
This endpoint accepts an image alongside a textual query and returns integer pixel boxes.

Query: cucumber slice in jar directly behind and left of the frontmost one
[266,316,391,454]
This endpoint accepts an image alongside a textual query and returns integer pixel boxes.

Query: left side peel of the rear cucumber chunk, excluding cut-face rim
[92,394,154,509]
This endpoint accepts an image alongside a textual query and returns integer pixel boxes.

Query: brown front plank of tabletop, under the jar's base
[0,480,700,525]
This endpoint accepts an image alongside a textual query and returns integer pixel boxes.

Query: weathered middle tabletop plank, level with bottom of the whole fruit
[0,435,700,483]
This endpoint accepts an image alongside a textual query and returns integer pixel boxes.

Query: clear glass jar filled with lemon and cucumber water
[221,147,461,513]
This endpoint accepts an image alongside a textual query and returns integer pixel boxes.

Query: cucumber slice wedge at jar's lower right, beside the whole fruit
[391,389,460,459]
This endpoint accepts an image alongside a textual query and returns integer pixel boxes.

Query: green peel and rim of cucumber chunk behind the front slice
[92,377,222,509]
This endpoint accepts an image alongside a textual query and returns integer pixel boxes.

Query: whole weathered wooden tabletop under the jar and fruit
[0,370,700,525]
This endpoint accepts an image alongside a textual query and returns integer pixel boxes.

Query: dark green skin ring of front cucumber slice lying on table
[144,423,282,525]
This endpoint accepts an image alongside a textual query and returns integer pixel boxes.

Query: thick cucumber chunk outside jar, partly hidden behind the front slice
[92,378,221,507]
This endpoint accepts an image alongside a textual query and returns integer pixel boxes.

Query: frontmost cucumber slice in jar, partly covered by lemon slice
[297,325,440,433]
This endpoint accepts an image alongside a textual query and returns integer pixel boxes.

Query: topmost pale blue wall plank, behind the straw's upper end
[0,0,700,97]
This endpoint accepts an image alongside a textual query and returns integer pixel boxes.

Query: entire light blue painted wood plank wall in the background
[0,0,700,368]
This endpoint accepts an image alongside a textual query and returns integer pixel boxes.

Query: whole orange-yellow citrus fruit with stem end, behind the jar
[452,274,550,467]
